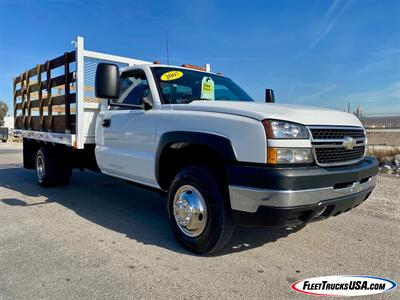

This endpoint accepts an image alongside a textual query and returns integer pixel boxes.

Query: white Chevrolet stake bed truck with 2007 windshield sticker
[14,37,378,254]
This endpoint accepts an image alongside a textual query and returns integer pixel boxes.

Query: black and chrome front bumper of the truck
[228,158,378,226]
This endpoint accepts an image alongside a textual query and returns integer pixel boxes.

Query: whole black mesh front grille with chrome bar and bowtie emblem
[309,126,366,166]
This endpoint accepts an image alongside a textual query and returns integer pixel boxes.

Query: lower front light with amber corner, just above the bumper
[267,147,313,164]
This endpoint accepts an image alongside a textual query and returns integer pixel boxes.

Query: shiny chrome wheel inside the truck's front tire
[173,185,208,237]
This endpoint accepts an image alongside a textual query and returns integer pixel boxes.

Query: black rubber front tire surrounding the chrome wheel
[167,165,234,255]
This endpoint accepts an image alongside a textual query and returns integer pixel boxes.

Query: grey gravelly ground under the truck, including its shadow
[0,144,400,299]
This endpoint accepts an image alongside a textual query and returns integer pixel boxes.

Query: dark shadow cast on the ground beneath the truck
[0,168,300,256]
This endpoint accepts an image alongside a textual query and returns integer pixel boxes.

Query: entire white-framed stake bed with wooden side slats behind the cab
[13,37,150,149]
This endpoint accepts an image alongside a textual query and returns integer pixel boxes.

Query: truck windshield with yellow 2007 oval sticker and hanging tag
[153,67,254,104]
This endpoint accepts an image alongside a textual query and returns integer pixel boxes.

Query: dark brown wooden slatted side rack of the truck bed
[13,51,76,134]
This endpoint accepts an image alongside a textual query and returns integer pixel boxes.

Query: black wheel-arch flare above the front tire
[155,131,237,182]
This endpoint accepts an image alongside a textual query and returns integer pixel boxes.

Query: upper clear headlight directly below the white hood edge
[262,120,308,139]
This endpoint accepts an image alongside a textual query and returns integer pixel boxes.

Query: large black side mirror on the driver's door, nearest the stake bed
[95,63,120,99]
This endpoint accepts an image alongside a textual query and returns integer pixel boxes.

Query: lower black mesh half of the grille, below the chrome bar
[315,146,365,164]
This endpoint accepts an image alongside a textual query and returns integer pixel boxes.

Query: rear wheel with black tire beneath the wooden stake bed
[35,147,72,187]
